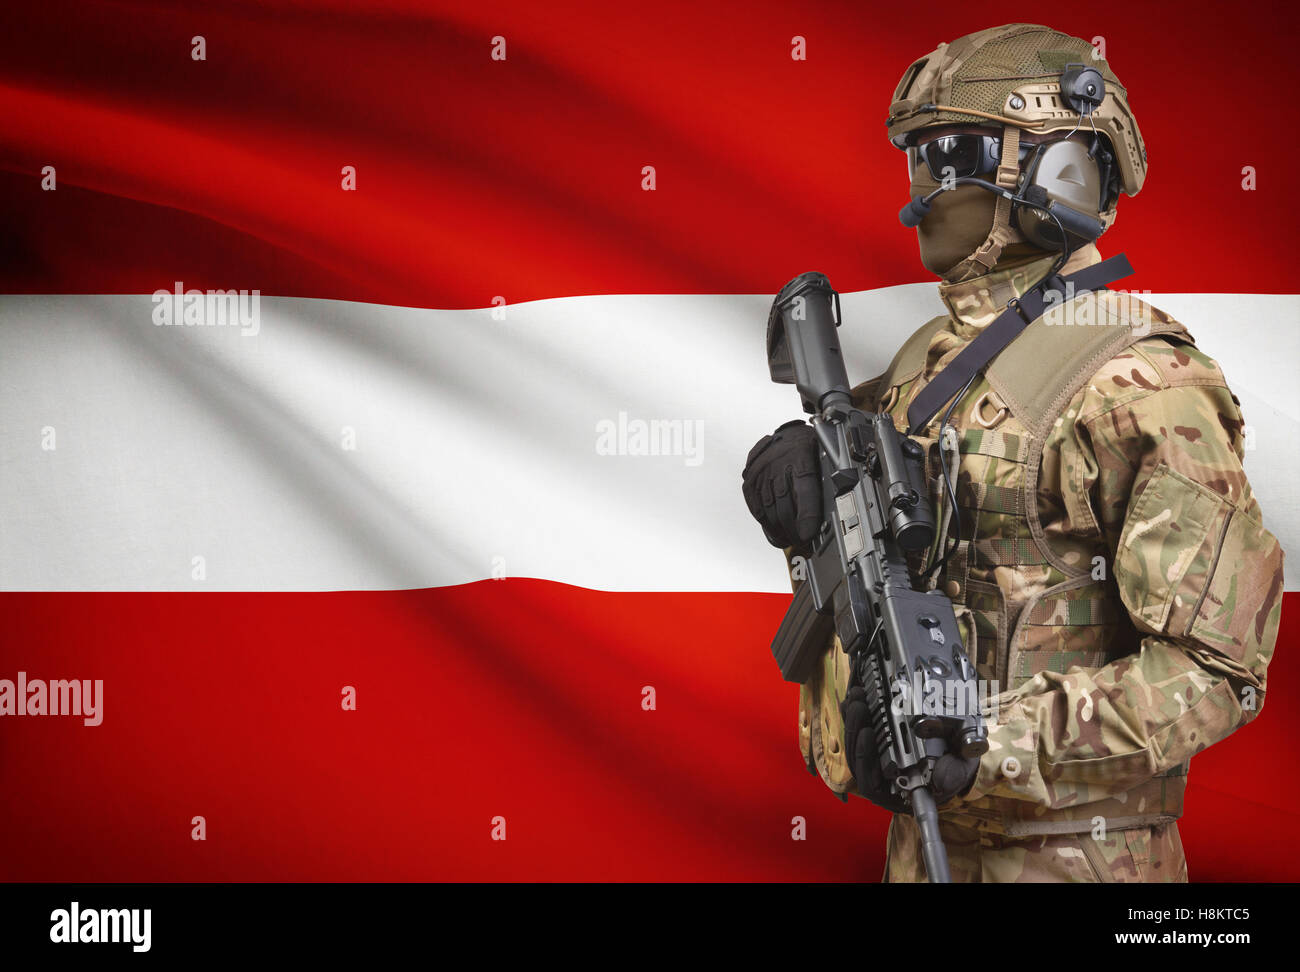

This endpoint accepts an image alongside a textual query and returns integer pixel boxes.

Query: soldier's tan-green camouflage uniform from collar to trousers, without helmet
[800,246,1282,881]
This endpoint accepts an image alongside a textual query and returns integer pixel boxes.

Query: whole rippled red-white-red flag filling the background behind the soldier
[0,0,1300,881]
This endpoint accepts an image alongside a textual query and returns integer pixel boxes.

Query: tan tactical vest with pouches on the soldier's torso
[816,291,1192,837]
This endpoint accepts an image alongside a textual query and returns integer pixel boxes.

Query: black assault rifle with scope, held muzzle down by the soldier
[767,273,988,882]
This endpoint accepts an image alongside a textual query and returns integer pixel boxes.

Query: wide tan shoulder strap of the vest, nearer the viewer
[984,291,1191,438]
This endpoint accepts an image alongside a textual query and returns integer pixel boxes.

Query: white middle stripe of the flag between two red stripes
[0,283,1300,591]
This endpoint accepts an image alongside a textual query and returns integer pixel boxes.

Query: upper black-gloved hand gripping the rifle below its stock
[741,418,822,552]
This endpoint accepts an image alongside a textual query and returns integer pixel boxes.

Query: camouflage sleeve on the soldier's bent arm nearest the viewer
[967,339,1283,808]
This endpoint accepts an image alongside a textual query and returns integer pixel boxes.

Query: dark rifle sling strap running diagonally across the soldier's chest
[907,253,1134,435]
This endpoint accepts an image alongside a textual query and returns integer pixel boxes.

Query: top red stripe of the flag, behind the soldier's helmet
[0,0,1295,307]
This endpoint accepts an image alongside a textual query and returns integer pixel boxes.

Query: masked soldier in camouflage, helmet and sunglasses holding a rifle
[744,23,1283,881]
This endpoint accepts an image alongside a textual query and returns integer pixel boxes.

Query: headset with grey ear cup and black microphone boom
[898,64,1119,252]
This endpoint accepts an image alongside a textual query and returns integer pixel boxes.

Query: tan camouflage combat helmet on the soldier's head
[885,23,1147,196]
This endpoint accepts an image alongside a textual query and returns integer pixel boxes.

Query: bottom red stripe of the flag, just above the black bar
[0,580,1300,881]
